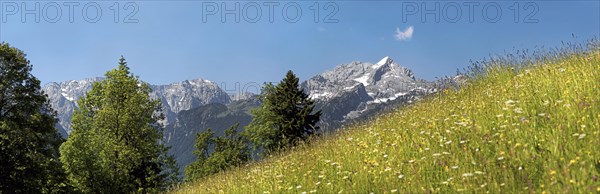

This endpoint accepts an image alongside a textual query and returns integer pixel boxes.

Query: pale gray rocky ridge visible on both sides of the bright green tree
[43,78,231,136]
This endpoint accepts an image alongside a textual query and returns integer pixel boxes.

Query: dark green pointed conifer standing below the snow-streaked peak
[246,71,321,154]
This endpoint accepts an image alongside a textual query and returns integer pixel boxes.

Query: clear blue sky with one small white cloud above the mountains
[0,0,600,85]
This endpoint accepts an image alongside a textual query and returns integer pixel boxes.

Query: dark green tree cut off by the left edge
[0,43,66,193]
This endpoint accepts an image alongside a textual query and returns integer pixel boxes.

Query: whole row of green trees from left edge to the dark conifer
[0,43,321,193]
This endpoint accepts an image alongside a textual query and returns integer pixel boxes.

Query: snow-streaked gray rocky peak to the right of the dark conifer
[301,57,435,130]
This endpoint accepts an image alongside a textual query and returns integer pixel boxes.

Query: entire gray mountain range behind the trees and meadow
[43,57,460,173]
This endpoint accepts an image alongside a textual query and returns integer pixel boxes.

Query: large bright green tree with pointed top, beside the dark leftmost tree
[60,57,177,193]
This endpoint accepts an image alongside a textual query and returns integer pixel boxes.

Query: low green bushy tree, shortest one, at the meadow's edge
[185,124,250,181]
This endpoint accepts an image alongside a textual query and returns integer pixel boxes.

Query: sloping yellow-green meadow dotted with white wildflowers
[175,51,600,193]
